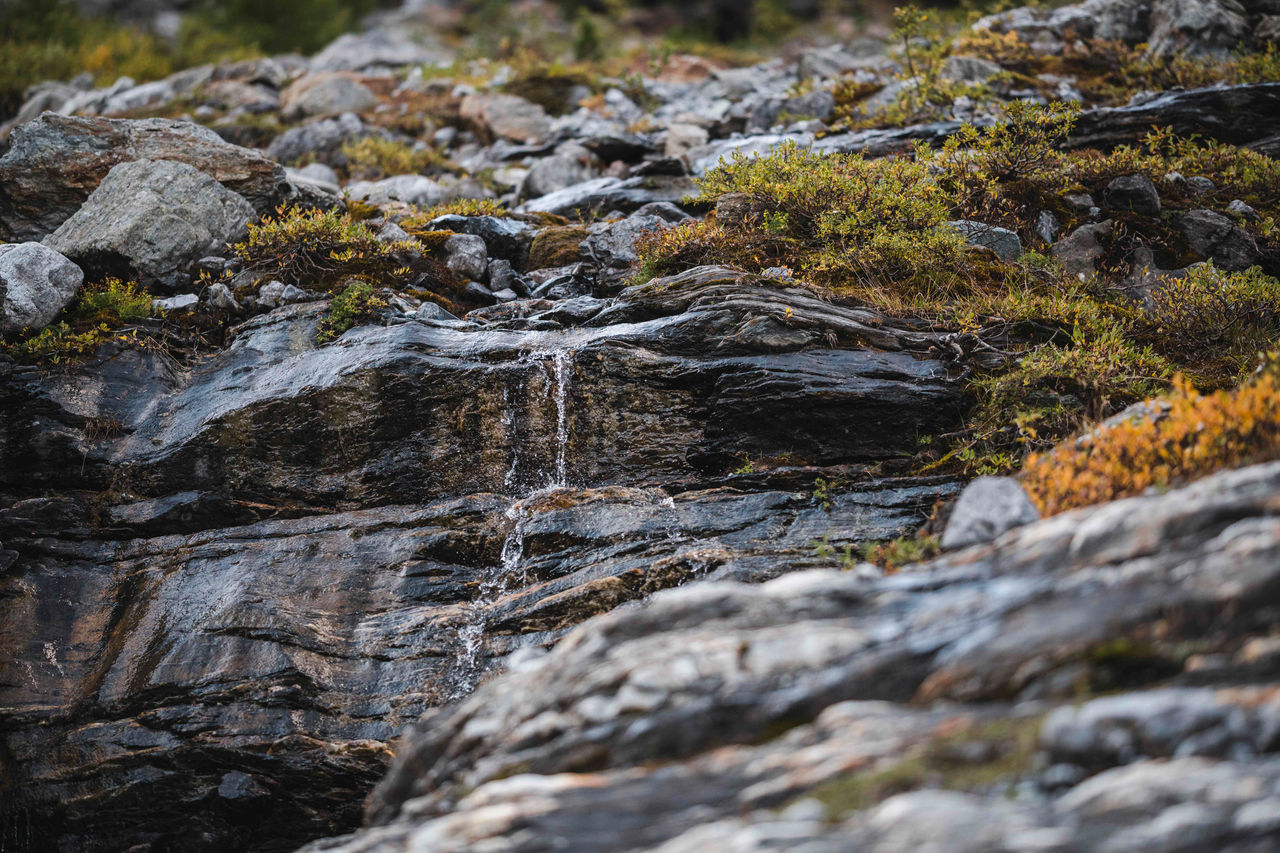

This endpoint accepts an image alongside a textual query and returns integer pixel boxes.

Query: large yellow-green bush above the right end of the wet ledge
[637,142,966,298]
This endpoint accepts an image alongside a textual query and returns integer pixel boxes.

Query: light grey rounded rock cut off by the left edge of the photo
[0,243,84,334]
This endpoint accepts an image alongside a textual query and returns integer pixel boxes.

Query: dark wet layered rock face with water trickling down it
[0,269,963,850]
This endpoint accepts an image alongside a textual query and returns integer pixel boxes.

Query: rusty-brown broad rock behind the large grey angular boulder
[0,114,288,240]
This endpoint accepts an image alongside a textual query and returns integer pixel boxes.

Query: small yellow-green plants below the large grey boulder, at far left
[13,278,151,364]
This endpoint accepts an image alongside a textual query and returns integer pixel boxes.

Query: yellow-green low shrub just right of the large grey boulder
[233,207,415,289]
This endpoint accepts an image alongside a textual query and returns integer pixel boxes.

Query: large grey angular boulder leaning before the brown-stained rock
[45,160,253,287]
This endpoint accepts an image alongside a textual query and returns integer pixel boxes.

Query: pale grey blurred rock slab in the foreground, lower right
[311,464,1280,853]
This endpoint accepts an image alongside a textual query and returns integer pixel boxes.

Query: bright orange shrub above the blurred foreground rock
[1024,370,1280,515]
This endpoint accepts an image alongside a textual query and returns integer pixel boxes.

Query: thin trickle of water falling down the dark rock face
[449,350,573,699]
